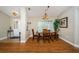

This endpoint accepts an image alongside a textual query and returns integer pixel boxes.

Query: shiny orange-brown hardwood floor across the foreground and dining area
[0,38,79,53]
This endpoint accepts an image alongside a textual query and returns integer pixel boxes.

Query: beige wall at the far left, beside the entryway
[0,12,10,40]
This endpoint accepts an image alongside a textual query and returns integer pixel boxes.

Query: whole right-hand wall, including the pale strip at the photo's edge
[59,7,79,47]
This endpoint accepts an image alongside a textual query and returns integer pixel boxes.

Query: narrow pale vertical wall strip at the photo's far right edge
[75,7,79,47]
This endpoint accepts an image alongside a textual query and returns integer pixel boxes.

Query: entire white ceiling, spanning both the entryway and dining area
[0,6,69,17]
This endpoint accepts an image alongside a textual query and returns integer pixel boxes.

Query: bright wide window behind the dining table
[37,21,54,32]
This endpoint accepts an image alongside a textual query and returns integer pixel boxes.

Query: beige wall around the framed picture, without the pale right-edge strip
[59,7,75,44]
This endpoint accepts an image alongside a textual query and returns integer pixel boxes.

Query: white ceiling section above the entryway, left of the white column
[0,6,20,17]
